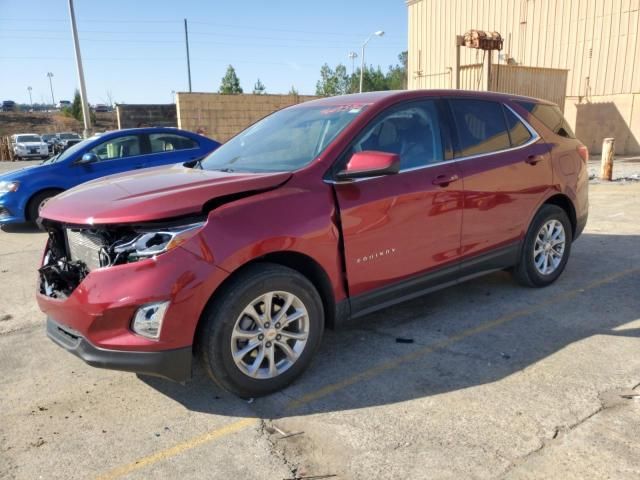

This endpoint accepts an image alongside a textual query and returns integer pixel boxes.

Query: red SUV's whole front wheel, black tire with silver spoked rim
[196,263,324,398]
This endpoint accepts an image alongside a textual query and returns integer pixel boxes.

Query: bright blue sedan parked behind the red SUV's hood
[0,128,220,224]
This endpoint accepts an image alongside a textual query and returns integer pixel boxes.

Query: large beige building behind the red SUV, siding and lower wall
[406,0,640,154]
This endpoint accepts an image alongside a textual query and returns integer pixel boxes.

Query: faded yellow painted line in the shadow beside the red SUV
[286,268,640,412]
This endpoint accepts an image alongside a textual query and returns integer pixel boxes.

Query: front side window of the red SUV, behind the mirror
[348,100,444,170]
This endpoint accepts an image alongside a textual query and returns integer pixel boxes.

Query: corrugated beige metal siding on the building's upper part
[407,0,640,96]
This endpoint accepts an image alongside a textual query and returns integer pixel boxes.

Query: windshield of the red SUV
[201,104,367,172]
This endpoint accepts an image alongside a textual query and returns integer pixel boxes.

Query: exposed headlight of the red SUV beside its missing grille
[113,222,205,261]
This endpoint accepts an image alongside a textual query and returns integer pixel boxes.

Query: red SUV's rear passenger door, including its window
[449,98,552,257]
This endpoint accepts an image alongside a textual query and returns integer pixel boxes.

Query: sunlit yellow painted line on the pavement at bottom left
[97,418,258,480]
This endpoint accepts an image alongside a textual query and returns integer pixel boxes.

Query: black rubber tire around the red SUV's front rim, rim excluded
[203,266,324,397]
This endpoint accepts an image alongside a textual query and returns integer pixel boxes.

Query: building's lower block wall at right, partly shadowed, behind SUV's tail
[564,93,640,155]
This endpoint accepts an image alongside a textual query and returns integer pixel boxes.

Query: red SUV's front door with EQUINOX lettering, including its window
[335,100,462,300]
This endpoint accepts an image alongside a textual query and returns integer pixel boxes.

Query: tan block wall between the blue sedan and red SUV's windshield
[176,92,318,142]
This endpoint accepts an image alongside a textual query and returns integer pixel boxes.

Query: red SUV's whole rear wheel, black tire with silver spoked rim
[513,205,573,287]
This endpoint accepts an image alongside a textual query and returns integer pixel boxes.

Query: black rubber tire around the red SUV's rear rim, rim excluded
[521,205,573,287]
